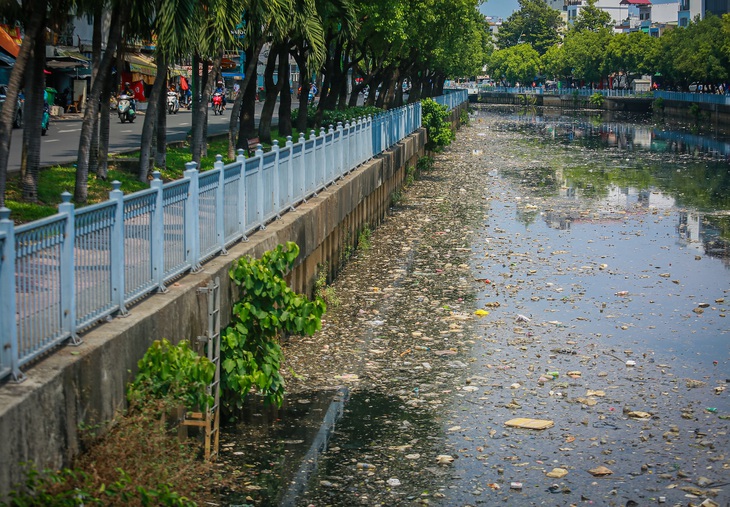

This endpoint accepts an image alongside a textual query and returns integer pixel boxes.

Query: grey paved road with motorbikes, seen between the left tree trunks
[8,102,263,172]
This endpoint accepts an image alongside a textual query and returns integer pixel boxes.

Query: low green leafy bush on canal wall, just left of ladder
[127,339,215,410]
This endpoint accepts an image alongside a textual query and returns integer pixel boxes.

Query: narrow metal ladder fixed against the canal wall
[181,277,221,461]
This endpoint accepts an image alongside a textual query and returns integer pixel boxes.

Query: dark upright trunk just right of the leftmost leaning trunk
[20,22,46,202]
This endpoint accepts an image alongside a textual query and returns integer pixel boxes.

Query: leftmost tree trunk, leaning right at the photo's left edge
[0,0,48,207]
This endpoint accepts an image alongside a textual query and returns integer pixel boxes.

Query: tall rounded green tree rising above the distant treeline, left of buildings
[497,0,563,55]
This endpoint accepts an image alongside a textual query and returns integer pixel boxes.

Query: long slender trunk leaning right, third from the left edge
[74,1,129,204]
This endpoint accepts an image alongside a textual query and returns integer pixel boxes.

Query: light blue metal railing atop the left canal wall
[0,93,467,381]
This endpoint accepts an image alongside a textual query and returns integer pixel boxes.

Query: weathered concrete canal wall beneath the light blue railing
[0,126,432,498]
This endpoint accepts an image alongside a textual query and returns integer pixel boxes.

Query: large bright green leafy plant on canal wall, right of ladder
[221,241,327,409]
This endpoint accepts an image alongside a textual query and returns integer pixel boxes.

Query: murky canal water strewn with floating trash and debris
[214,108,730,507]
